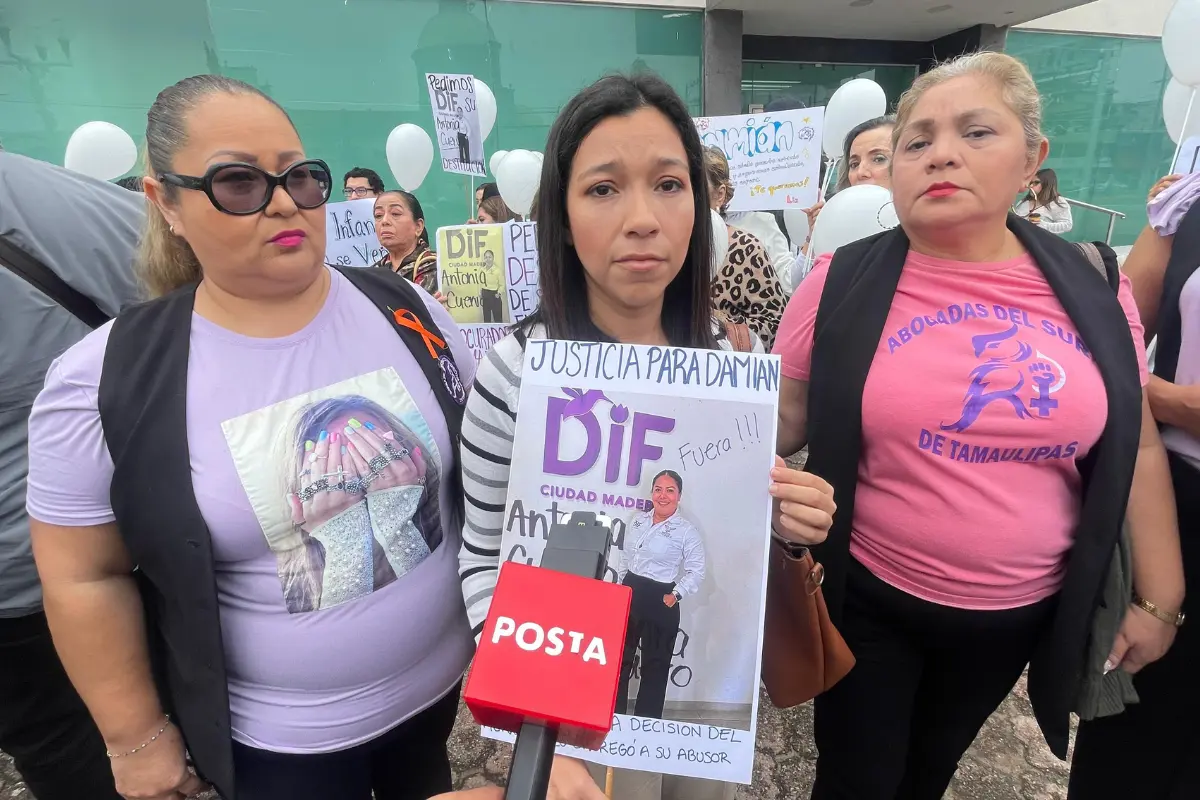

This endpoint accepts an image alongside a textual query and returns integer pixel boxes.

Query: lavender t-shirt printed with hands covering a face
[28,271,475,753]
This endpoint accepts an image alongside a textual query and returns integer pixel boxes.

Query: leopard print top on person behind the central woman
[713,228,787,353]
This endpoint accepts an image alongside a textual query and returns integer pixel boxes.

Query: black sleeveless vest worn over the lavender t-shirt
[100,267,467,800]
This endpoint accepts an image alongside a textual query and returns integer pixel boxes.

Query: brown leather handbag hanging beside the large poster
[762,535,854,709]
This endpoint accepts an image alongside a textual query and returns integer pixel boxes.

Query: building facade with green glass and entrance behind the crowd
[0,0,1172,243]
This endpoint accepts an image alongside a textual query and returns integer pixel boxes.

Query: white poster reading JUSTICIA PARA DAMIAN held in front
[484,339,780,783]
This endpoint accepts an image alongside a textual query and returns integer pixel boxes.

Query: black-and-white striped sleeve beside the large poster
[458,336,524,640]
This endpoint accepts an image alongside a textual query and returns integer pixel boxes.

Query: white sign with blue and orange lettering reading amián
[694,108,824,211]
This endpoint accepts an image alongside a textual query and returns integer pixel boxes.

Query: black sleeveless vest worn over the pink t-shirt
[806,215,1141,758]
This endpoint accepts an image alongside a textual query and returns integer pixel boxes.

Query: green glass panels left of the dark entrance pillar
[0,0,703,236]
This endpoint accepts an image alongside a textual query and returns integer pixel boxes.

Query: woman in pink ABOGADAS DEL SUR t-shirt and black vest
[775,53,1183,800]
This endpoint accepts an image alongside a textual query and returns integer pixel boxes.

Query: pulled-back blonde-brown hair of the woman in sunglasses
[137,76,290,297]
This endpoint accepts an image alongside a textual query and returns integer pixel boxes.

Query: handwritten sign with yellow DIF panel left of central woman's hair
[438,222,541,360]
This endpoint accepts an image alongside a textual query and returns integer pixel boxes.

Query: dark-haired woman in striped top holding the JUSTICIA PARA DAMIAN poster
[460,76,834,800]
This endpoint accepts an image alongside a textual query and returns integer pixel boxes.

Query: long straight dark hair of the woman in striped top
[520,73,716,350]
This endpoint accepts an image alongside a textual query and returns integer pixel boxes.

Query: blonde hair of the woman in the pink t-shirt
[892,50,1045,158]
